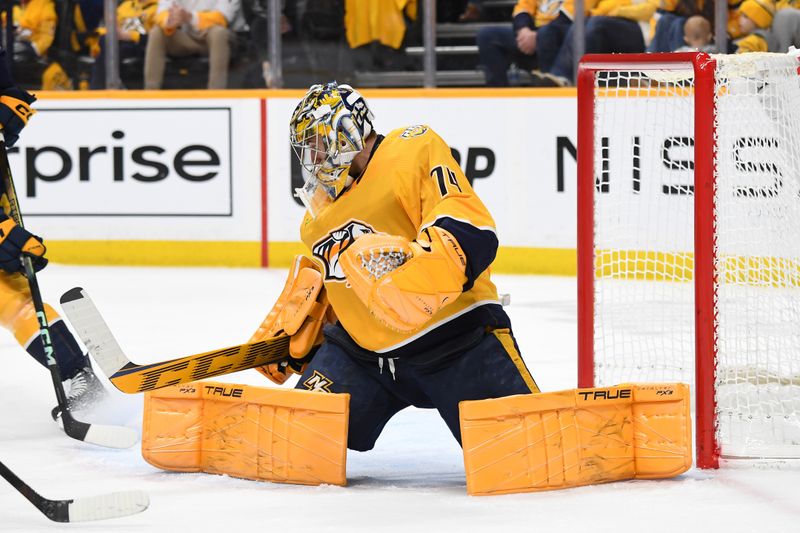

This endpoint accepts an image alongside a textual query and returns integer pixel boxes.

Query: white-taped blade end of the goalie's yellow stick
[61,287,130,376]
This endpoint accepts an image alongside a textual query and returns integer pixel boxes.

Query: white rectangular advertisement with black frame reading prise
[11,107,233,217]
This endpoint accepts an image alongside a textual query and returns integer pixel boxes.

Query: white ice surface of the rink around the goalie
[0,265,800,533]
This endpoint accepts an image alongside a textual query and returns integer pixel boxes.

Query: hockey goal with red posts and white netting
[578,53,800,467]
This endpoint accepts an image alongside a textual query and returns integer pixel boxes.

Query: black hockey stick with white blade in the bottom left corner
[0,462,150,522]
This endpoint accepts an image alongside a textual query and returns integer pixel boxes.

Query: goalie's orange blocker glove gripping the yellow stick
[250,255,336,385]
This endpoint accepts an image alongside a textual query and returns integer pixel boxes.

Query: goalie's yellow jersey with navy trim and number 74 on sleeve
[301,126,509,356]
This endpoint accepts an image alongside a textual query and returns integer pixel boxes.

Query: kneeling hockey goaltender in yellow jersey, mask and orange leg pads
[142,82,691,494]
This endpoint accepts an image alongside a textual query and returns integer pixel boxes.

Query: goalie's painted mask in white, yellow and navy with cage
[289,82,373,216]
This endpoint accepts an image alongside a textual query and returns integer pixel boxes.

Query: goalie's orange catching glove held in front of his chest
[339,226,467,332]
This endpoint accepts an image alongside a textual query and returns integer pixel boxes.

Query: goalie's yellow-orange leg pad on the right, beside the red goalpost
[459,383,692,495]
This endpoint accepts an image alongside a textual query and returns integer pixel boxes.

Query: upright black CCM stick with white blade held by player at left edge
[0,139,138,448]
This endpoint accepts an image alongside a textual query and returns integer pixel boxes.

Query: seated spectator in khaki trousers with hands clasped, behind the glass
[144,0,240,89]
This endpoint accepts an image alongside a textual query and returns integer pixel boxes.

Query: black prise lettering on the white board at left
[9,130,220,198]
